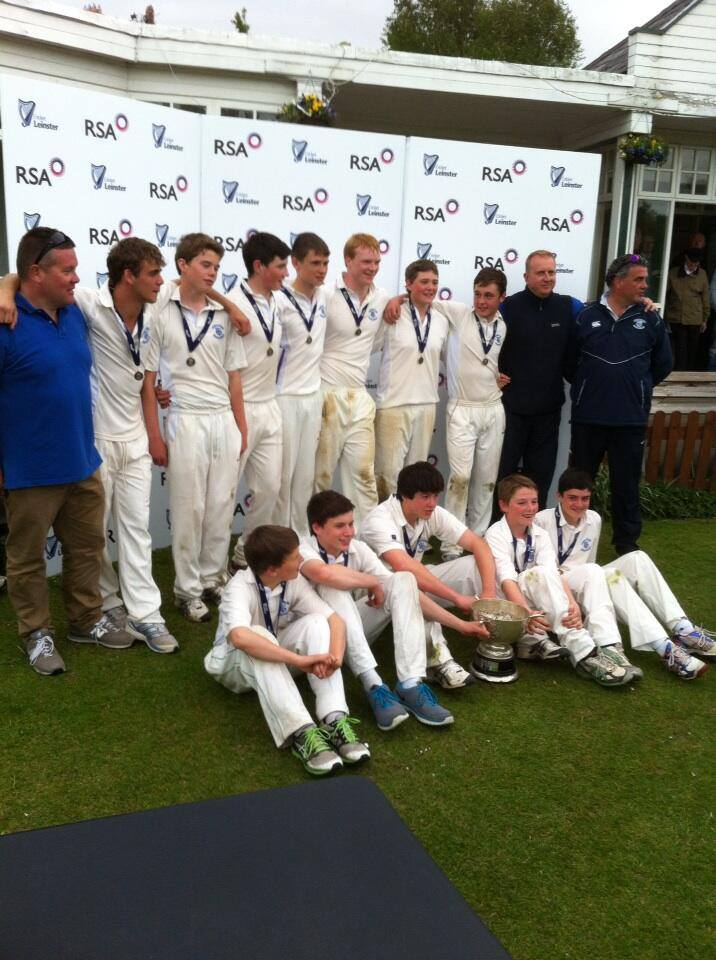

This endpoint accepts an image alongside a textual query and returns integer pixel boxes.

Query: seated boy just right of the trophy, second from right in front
[485,474,633,687]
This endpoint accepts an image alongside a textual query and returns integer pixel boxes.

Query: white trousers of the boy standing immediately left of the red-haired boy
[274,390,323,540]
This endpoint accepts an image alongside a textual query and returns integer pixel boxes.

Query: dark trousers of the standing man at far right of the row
[571,423,646,556]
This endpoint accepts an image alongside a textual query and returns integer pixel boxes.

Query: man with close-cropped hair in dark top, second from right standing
[494,250,583,510]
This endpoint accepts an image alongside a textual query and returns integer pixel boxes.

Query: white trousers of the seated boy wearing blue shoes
[316,571,451,680]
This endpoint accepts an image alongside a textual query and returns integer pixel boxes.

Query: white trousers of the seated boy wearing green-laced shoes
[204,614,348,747]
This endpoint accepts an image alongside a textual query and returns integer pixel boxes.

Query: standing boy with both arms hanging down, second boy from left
[142,233,246,622]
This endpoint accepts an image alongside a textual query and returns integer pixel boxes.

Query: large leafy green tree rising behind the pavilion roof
[383,0,582,67]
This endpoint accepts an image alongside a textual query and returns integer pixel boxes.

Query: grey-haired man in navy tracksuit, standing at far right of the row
[571,253,673,555]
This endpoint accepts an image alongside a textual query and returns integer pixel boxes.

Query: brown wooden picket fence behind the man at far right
[644,410,716,492]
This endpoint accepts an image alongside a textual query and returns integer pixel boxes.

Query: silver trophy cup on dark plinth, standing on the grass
[470,600,530,683]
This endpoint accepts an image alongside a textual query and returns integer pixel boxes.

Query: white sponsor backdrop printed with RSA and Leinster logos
[1,76,599,572]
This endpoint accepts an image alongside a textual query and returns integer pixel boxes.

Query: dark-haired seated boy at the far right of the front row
[535,469,716,680]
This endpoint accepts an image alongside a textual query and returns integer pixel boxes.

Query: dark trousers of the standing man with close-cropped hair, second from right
[497,410,562,517]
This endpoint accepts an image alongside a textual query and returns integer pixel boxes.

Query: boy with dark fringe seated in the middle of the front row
[359,461,496,690]
